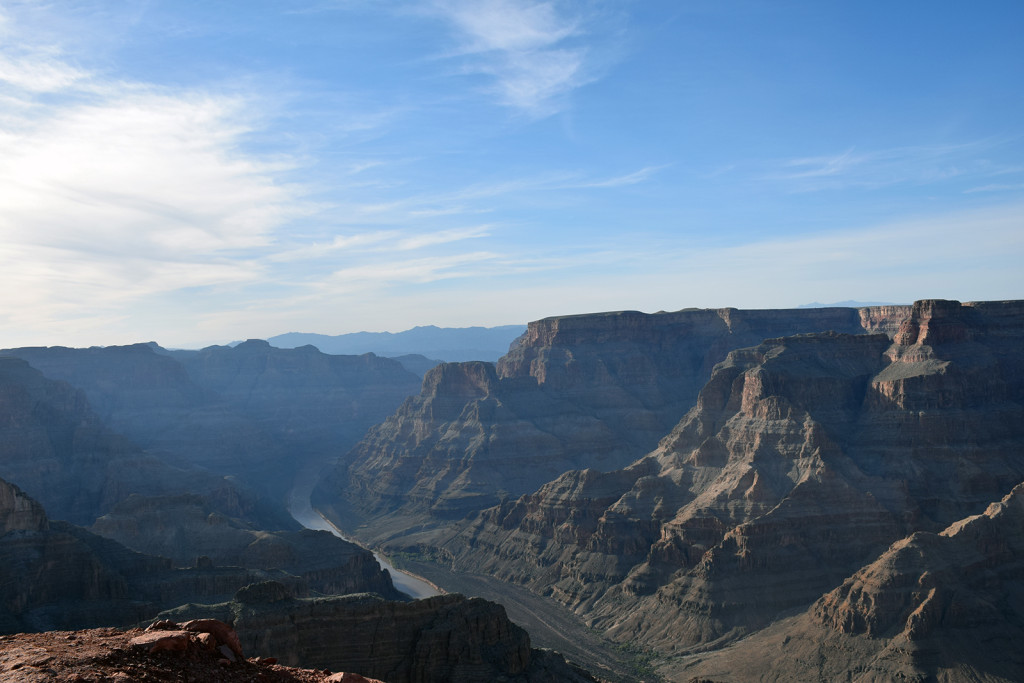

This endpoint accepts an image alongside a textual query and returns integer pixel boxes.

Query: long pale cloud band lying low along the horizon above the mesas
[197,200,1024,344]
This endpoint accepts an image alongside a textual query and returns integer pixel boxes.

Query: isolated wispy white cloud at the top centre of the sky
[435,0,596,117]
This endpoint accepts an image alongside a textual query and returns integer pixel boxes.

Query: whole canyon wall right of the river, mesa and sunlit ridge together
[316,300,1024,680]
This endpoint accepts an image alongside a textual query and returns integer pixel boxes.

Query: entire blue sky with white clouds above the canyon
[0,0,1024,347]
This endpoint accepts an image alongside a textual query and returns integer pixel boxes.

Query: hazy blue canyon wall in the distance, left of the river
[2,340,420,496]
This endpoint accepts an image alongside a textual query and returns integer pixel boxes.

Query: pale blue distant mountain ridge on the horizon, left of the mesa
[249,325,526,362]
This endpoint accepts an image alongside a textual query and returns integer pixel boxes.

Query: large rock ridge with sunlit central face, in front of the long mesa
[420,301,1024,652]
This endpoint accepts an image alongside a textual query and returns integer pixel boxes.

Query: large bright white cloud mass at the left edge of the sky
[0,7,309,344]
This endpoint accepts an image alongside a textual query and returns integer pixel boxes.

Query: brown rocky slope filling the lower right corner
[669,484,1024,683]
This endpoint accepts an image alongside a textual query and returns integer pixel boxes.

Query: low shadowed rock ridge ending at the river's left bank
[91,495,400,599]
